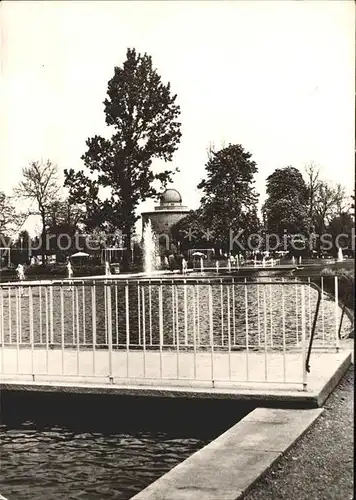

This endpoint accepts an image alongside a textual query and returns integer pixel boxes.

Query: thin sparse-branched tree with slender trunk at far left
[14,160,60,264]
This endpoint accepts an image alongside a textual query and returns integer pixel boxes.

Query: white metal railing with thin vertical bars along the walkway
[0,276,350,388]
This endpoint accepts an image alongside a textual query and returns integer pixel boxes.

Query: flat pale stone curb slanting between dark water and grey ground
[131,408,323,500]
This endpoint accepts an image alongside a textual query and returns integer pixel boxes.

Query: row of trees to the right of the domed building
[173,144,355,256]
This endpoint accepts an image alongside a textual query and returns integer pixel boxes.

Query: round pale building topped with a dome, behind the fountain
[142,189,190,245]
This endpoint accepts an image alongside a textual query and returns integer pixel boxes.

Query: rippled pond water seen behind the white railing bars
[0,278,351,349]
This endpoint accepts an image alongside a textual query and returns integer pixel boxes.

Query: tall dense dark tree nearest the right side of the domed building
[198,144,259,251]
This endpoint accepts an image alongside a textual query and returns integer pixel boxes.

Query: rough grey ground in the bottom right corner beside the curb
[244,366,354,500]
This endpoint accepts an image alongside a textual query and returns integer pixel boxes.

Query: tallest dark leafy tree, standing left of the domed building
[65,49,181,268]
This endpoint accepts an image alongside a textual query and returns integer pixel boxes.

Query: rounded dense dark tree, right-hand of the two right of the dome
[262,166,309,237]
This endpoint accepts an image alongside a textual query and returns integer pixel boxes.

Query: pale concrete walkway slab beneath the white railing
[0,348,351,407]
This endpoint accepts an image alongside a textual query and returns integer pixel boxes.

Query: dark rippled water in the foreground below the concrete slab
[0,392,249,500]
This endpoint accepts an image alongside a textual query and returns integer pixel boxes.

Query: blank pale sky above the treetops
[0,0,355,235]
